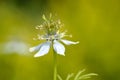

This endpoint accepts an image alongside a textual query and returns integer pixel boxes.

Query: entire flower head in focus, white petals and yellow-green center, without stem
[29,16,79,57]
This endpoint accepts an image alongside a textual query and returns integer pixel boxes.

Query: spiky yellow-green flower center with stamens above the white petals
[35,15,71,41]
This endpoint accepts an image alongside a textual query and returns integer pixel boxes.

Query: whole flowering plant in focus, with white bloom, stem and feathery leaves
[29,14,97,80]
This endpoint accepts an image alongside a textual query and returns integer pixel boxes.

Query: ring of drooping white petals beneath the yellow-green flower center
[29,32,79,57]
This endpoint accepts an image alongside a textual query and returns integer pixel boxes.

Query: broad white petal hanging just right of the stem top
[53,40,65,55]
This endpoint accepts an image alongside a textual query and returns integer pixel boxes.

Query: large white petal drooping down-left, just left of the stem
[34,42,50,57]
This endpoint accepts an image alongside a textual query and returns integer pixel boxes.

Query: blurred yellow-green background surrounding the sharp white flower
[0,0,120,80]
